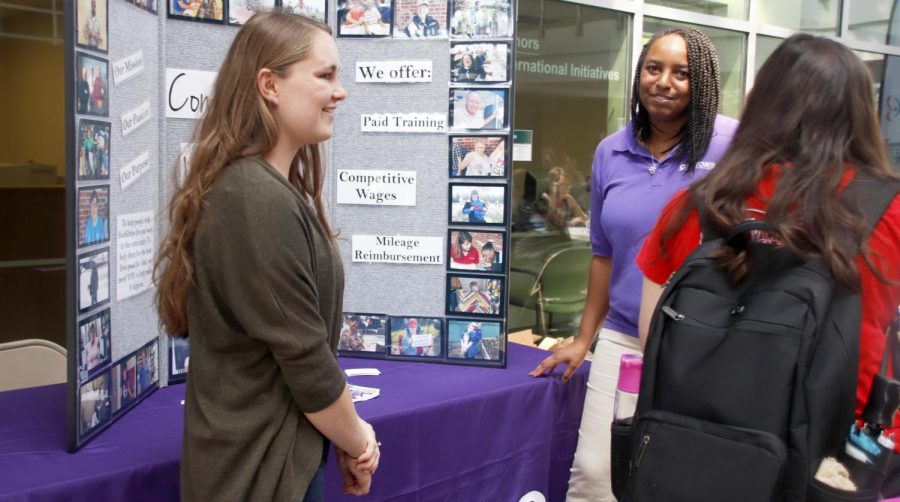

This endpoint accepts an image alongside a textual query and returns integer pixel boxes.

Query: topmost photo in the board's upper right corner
[450,0,515,38]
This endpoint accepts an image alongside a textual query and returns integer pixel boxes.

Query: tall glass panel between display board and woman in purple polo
[510,0,631,335]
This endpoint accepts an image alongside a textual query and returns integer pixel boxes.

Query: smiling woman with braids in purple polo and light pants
[530,28,737,501]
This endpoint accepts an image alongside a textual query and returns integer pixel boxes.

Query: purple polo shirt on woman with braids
[591,115,738,336]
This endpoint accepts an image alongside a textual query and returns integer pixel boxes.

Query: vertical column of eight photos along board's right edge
[444,0,515,366]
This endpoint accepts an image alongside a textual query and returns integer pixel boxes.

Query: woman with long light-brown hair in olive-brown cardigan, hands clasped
[156,12,379,500]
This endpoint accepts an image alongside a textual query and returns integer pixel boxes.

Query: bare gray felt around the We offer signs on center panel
[326,38,458,317]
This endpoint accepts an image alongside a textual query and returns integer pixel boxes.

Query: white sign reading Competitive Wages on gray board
[337,169,416,206]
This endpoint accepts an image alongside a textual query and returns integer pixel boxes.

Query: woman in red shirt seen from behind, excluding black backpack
[637,34,900,488]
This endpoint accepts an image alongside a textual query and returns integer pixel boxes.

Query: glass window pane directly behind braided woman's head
[643,17,747,118]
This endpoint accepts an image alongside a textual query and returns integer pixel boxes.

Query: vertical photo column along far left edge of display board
[69,0,113,452]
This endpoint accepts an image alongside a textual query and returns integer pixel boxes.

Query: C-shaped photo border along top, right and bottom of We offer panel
[335,0,515,366]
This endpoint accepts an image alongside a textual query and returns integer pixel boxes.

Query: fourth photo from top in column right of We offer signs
[450,136,508,178]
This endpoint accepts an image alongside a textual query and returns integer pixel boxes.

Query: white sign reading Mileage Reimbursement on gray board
[351,235,444,265]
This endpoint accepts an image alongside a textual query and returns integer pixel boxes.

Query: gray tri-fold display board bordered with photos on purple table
[66,0,516,451]
